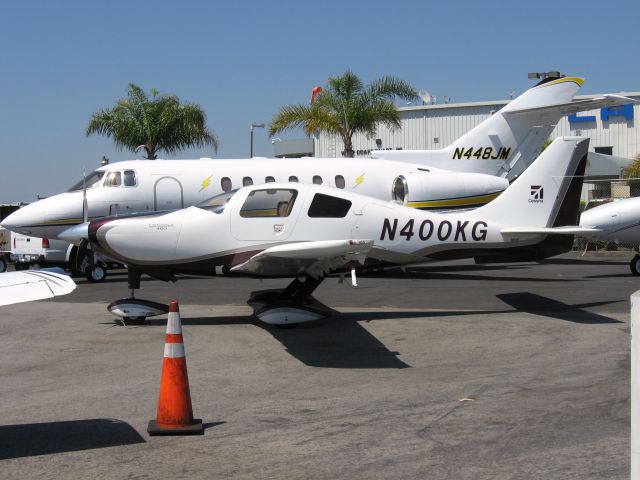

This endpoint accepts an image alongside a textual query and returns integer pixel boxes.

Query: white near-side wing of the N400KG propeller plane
[231,240,373,278]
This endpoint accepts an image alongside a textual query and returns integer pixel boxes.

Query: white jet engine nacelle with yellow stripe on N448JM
[392,172,509,210]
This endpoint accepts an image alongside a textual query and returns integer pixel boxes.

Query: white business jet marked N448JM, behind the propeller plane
[2,77,635,248]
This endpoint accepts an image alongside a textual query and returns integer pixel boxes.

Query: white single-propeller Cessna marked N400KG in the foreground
[60,138,589,324]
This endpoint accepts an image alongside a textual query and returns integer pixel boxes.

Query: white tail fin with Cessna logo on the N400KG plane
[474,137,589,232]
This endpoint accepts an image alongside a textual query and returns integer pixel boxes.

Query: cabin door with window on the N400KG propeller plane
[231,188,302,241]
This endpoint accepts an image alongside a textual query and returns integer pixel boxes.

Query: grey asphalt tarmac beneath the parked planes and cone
[0,254,640,480]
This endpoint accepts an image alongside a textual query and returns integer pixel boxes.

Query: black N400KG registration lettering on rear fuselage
[380,218,488,242]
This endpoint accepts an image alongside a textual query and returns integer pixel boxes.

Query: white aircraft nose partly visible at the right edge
[580,197,640,275]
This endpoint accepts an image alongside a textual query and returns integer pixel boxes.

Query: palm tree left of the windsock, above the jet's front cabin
[86,83,218,160]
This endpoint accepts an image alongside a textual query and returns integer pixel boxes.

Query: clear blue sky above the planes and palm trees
[0,0,640,202]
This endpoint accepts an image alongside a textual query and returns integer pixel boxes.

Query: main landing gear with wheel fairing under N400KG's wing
[247,276,335,325]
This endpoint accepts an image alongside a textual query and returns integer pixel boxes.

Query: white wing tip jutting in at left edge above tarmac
[0,269,76,306]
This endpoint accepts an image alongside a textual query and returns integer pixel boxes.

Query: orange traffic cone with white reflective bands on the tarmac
[147,301,204,435]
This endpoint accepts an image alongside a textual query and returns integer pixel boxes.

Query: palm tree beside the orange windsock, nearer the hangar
[269,70,418,157]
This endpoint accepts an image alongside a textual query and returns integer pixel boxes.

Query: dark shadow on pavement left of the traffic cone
[0,418,145,460]
